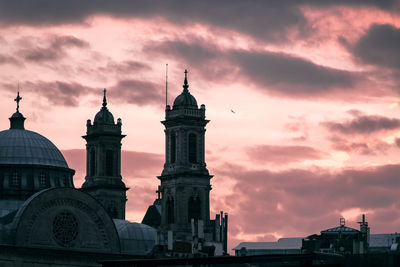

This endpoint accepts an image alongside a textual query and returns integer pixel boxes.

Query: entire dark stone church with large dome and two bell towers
[0,71,228,266]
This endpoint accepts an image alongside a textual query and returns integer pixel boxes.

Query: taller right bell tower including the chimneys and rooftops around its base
[143,71,228,256]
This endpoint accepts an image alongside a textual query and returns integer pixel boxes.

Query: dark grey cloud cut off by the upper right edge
[351,24,400,70]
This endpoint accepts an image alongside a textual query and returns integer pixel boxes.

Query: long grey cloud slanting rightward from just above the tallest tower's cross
[144,37,363,97]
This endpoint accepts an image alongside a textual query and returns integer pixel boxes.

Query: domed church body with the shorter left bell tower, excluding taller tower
[0,91,156,266]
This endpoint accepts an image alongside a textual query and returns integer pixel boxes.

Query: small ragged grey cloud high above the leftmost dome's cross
[17,36,89,62]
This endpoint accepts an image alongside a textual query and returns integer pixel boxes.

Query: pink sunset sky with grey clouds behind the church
[0,0,400,253]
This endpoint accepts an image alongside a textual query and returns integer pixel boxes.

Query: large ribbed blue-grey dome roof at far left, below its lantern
[0,129,68,168]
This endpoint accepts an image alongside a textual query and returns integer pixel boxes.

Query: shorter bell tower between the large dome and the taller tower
[82,89,128,219]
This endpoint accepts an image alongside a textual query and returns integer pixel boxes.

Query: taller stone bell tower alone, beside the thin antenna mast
[158,70,212,241]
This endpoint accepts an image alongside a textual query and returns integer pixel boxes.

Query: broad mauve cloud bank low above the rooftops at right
[216,165,400,243]
